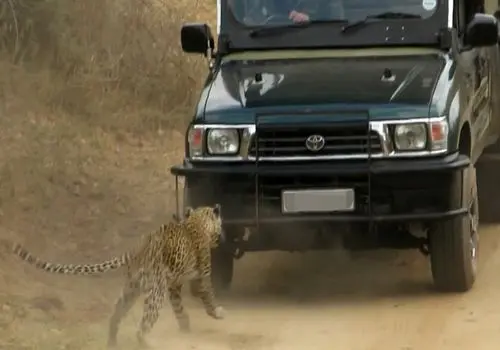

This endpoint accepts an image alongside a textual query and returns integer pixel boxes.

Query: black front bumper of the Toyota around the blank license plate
[171,153,470,226]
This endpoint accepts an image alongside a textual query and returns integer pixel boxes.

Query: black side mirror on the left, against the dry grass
[181,23,215,56]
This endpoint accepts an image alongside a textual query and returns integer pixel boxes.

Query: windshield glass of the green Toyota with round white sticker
[228,0,438,27]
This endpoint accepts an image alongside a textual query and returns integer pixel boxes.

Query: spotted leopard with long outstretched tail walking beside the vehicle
[3,204,225,349]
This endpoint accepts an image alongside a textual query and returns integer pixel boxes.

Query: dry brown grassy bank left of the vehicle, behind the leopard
[0,0,215,350]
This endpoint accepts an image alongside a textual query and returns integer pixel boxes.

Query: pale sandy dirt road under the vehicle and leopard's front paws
[107,226,494,350]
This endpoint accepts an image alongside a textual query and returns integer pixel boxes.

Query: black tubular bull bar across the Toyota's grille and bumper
[171,111,470,230]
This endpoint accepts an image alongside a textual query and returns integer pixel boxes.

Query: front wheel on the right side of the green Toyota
[429,165,479,292]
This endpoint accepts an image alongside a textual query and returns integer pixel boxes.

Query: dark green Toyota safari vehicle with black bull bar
[171,0,500,291]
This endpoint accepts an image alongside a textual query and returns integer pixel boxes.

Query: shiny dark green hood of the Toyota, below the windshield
[200,54,445,123]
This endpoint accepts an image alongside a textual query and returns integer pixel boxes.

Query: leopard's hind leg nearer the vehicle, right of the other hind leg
[137,281,166,348]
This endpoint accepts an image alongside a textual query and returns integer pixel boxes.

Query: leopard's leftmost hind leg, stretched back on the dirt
[108,278,141,348]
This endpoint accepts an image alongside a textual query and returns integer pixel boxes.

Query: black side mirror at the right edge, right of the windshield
[466,13,498,47]
